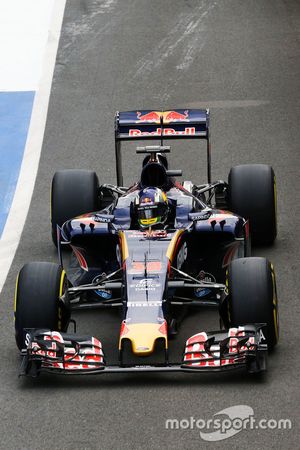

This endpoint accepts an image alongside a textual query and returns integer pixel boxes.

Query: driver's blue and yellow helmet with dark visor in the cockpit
[135,187,169,228]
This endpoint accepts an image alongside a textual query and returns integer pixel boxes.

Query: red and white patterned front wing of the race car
[20,324,268,377]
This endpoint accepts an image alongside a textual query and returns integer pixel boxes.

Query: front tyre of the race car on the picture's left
[15,262,69,350]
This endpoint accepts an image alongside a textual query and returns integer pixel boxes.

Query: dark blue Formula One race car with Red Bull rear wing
[15,109,279,376]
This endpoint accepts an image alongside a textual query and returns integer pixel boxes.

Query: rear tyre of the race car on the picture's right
[228,164,277,244]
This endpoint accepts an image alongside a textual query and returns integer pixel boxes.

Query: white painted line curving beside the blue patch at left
[0,0,66,292]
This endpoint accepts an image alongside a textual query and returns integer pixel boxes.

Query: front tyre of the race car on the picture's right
[227,257,279,348]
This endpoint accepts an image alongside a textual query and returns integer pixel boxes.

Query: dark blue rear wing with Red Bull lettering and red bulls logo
[115,109,211,186]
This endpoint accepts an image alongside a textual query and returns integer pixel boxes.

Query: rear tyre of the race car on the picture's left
[51,170,99,245]
